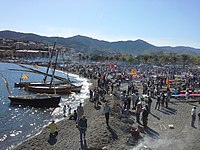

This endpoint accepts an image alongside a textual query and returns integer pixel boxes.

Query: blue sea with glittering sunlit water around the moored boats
[0,63,91,150]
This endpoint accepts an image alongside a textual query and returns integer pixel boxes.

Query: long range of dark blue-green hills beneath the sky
[0,30,200,55]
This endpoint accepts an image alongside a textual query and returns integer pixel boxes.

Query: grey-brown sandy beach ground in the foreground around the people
[14,80,200,150]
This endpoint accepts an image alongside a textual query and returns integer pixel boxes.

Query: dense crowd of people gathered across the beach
[49,64,200,143]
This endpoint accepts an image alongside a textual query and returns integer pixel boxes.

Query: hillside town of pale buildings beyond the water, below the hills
[0,39,85,65]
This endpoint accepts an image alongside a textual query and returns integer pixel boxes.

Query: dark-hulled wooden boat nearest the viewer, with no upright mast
[8,94,61,107]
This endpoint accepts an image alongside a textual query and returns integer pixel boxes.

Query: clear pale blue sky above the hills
[0,0,200,48]
